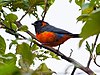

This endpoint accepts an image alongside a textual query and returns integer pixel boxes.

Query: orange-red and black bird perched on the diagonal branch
[32,20,80,50]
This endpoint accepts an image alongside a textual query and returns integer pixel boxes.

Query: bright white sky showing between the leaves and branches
[2,0,100,75]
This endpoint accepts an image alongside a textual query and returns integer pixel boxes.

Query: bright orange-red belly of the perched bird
[36,32,70,47]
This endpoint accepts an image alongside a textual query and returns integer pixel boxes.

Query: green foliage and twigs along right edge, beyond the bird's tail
[75,0,100,73]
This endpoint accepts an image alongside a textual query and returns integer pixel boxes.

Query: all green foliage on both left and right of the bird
[0,0,100,75]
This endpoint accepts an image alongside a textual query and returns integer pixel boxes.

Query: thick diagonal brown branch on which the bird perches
[16,22,95,75]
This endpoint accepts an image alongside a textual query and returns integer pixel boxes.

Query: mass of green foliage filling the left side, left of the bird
[0,0,55,75]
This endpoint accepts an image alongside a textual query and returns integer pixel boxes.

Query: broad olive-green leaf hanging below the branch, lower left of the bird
[16,43,33,65]
